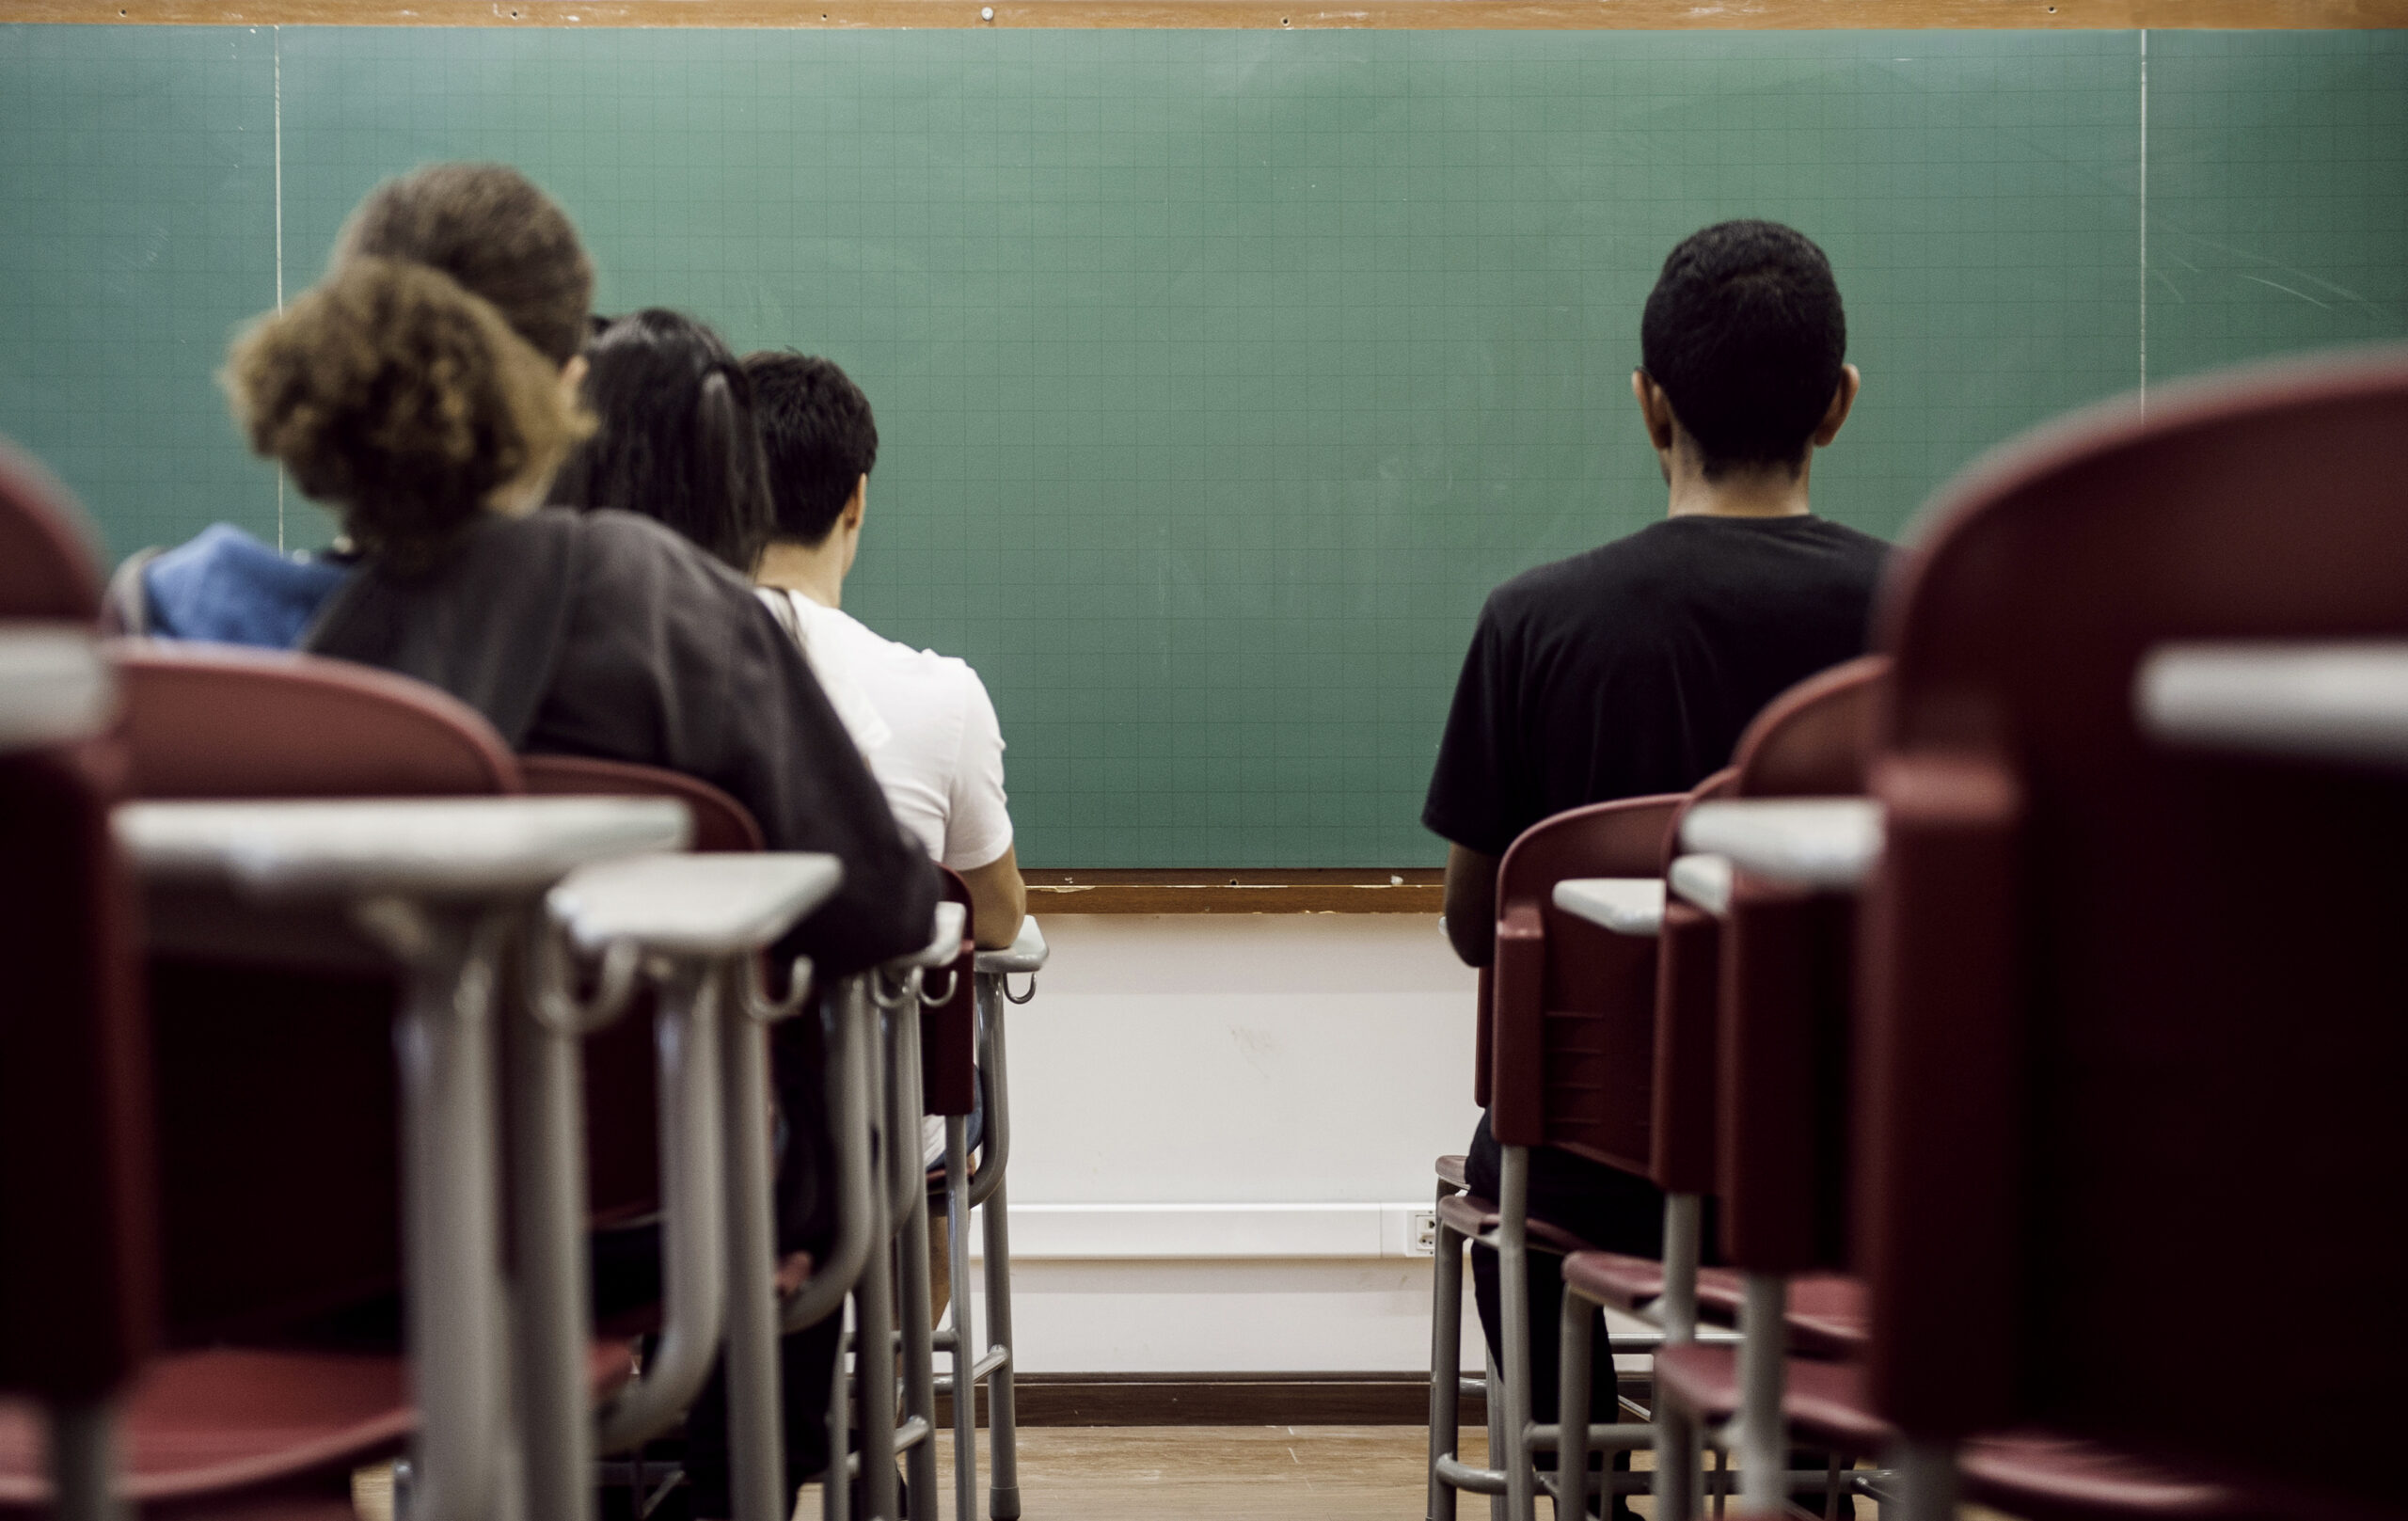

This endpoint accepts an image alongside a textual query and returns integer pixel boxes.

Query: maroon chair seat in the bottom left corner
[0,1340,636,1516]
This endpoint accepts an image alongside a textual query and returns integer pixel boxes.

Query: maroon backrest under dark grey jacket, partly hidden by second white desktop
[517,755,761,1225]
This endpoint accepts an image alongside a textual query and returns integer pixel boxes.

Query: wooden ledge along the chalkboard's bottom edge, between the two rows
[1021,866,1448,914]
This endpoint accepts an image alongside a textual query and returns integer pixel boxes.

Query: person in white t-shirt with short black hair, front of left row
[744,354,1028,948]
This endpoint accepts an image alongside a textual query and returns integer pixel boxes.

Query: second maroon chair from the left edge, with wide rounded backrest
[0,641,631,1521]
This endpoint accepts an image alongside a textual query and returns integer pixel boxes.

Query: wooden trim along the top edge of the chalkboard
[0,0,2408,31]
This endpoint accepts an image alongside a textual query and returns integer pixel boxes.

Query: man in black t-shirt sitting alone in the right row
[1420,221,1888,1511]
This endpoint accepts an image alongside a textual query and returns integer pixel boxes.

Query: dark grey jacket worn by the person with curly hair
[301,508,937,974]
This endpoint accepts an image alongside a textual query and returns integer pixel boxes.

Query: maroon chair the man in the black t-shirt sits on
[1431,797,1681,1516]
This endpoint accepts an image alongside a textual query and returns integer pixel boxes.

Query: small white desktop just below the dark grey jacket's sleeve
[545,854,846,956]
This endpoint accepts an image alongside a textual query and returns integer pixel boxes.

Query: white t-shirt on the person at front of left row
[758,587,1011,871]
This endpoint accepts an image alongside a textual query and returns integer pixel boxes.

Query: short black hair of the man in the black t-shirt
[1640,221,1847,479]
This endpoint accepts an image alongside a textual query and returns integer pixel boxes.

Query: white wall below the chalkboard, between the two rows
[953,914,1479,1371]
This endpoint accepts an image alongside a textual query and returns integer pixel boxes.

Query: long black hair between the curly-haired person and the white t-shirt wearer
[549,306,770,575]
